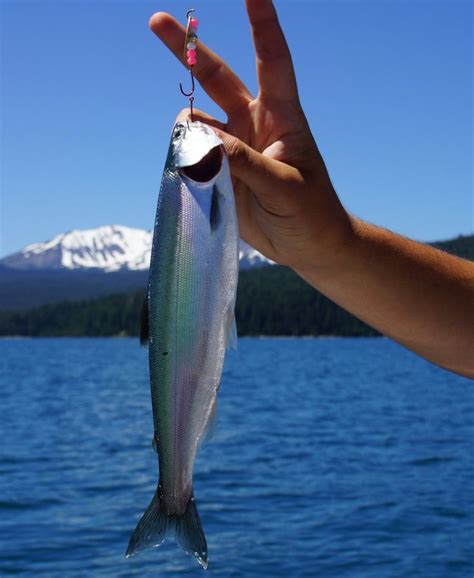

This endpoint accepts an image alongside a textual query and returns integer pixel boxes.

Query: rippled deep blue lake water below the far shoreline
[0,339,474,578]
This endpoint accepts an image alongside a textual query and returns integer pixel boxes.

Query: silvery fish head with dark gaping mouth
[168,121,225,183]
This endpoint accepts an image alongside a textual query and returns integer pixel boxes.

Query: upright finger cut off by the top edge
[246,0,298,100]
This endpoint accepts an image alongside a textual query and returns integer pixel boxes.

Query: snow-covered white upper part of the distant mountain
[0,225,272,272]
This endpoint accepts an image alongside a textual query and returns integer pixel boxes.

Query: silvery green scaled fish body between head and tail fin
[149,168,236,515]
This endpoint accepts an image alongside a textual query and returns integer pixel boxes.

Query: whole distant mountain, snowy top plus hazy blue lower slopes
[0,225,273,311]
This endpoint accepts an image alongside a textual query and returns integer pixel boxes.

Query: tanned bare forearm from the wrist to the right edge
[297,219,474,377]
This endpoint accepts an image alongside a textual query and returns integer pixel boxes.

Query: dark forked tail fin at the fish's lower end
[125,491,207,570]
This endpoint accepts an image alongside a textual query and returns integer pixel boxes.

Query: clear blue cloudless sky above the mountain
[0,0,473,256]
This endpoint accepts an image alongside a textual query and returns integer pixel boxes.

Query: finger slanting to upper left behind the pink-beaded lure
[150,12,252,115]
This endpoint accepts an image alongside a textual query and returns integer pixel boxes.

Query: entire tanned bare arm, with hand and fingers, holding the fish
[150,0,474,377]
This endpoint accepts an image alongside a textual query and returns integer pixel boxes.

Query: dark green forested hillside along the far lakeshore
[0,236,474,336]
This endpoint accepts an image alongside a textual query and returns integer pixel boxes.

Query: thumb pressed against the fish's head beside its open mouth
[215,129,303,216]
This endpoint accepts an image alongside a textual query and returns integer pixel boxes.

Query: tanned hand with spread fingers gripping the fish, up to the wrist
[150,0,352,270]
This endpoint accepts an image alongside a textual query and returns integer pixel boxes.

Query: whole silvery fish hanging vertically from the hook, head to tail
[126,121,239,569]
